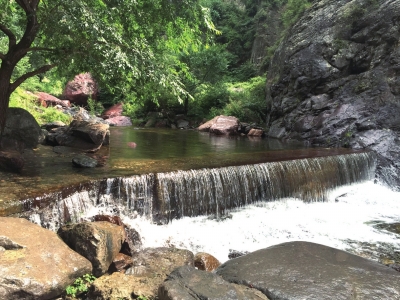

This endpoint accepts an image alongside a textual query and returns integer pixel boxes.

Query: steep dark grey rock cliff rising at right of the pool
[267,0,400,189]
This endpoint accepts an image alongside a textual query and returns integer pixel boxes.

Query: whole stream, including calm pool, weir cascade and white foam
[0,128,400,262]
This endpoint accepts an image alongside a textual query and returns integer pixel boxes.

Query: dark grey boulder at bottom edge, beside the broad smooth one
[158,266,268,300]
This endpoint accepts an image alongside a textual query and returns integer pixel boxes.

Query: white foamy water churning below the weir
[85,182,400,262]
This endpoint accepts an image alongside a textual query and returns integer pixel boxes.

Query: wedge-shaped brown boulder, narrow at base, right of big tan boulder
[57,222,125,277]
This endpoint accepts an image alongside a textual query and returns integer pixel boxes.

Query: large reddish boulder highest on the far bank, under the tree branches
[64,73,98,105]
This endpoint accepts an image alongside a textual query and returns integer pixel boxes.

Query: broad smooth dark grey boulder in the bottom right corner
[216,242,400,300]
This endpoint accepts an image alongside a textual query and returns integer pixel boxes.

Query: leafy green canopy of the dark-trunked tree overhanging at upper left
[0,0,214,131]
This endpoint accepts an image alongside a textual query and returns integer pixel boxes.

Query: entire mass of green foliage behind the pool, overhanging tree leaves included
[0,0,311,125]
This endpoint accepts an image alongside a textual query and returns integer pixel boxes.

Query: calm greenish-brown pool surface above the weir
[0,127,364,216]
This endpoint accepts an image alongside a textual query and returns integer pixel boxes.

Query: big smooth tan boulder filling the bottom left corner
[0,217,92,300]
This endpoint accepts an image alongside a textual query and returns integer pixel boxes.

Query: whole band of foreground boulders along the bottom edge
[0,216,400,300]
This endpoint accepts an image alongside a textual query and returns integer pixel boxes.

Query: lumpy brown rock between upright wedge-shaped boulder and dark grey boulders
[88,248,193,300]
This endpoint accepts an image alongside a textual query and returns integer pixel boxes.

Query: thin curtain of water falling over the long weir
[27,152,376,227]
